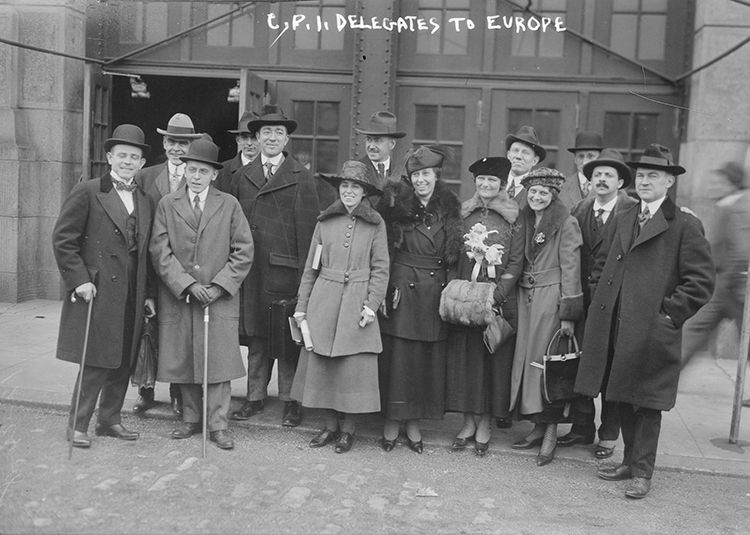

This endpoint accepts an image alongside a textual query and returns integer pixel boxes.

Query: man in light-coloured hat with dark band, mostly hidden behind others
[133,113,204,416]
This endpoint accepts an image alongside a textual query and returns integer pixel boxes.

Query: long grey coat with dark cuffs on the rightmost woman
[510,199,583,415]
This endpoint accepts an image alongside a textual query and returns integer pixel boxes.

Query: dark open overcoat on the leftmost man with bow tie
[52,173,154,368]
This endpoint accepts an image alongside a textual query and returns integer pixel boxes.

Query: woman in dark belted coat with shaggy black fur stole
[378,147,463,453]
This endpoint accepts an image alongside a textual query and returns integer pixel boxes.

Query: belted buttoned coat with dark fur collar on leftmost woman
[296,199,388,357]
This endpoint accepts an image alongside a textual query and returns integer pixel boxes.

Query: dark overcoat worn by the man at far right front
[575,197,714,410]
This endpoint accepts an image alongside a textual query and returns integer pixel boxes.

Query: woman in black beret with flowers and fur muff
[445,157,524,456]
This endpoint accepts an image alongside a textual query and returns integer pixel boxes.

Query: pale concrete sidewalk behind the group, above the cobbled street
[0,301,750,477]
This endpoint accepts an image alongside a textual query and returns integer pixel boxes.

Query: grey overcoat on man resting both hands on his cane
[150,187,253,384]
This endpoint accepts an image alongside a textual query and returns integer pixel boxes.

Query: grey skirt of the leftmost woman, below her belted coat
[291,348,380,414]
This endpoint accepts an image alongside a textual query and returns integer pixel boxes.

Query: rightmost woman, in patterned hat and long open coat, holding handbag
[510,167,583,466]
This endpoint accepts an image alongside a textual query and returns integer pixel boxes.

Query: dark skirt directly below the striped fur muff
[445,325,516,418]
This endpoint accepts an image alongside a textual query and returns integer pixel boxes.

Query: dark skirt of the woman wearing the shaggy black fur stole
[378,334,447,421]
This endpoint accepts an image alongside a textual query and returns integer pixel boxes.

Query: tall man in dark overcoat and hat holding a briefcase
[231,104,328,427]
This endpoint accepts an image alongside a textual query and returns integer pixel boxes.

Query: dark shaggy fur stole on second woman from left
[378,180,464,266]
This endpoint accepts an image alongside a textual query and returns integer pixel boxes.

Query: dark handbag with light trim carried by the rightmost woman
[542,329,581,403]
